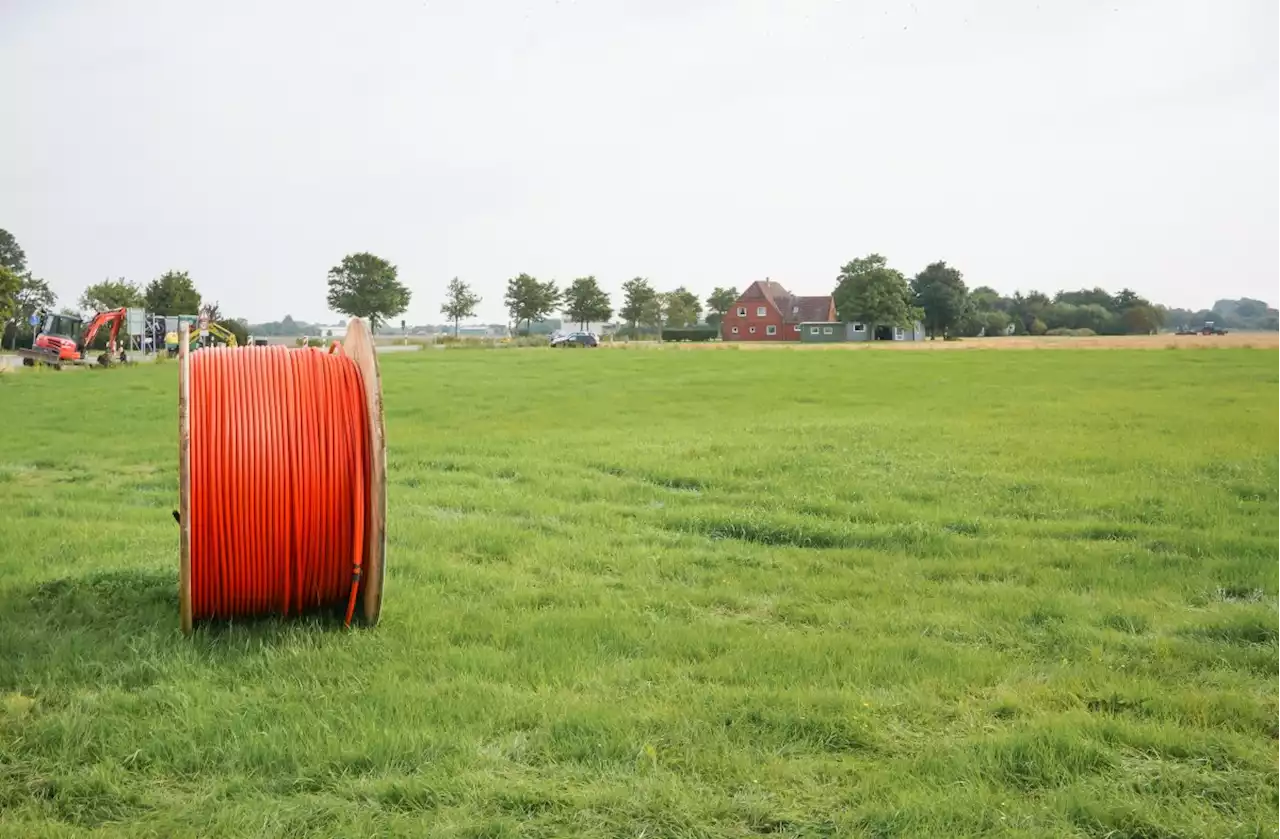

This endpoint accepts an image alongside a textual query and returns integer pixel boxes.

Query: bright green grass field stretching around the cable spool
[0,350,1280,839]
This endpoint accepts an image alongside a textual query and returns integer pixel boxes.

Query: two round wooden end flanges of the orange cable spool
[178,318,387,635]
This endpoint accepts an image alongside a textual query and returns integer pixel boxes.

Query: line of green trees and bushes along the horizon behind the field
[0,229,1280,346]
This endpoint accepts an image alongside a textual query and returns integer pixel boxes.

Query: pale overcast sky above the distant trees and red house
[0,0,1280,323]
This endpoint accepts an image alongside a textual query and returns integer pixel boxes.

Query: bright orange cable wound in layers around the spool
[189,343,370,626]
